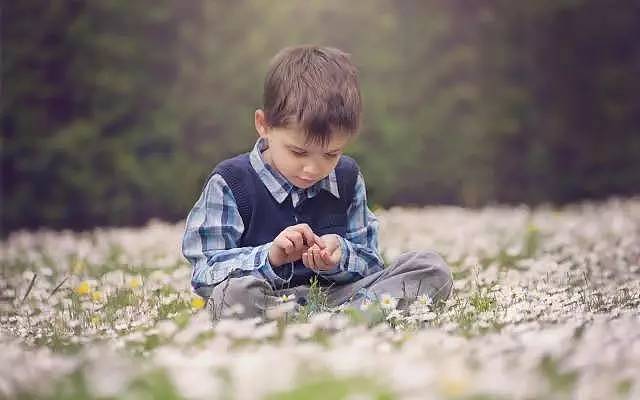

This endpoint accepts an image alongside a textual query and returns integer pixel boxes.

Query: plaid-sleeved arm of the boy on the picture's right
[320,173,384,283]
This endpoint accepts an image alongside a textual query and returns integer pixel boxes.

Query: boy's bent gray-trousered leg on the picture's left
[209,275,308,320]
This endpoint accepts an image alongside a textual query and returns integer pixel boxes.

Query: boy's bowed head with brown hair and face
[255,46,362,188]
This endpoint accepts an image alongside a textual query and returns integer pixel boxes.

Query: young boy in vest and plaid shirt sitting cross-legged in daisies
[182,46,453,318]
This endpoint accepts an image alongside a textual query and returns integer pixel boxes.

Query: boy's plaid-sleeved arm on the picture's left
[182,174,286,295]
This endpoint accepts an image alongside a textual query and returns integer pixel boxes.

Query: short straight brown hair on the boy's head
[263,45,362,146]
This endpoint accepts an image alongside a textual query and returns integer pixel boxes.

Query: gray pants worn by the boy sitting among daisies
[209,251,453,319]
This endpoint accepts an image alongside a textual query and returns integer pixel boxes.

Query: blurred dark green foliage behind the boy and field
[1,0,640,233]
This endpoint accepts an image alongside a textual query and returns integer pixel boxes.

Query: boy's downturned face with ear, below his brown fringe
[255,110,350,189]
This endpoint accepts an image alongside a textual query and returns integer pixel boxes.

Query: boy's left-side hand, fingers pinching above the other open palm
[269,224,325,267]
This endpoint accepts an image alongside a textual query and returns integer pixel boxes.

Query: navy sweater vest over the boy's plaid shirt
[212,153,358,287]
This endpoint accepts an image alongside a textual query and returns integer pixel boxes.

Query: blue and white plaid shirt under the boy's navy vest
[182,138,383,290]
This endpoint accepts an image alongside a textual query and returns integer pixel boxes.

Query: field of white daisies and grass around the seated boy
[0,198,640,400]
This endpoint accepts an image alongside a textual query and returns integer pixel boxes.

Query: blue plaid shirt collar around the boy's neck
[249,137,340,203]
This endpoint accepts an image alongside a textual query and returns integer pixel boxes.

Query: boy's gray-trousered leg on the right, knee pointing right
[328,251,453,307]
